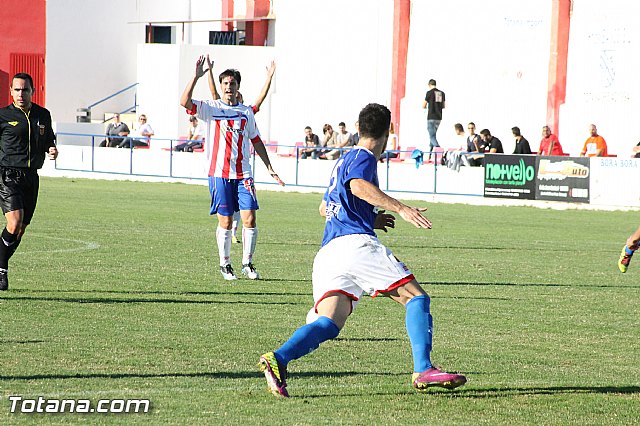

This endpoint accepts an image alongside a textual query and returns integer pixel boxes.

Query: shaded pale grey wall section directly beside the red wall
[46,0,144,122]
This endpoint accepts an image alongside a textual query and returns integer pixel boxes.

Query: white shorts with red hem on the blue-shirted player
[313,234,414,311]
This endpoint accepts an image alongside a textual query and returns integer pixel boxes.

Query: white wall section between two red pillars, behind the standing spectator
[400,0,551,152]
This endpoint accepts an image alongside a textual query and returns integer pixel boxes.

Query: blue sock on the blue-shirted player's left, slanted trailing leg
[274,317,340,366]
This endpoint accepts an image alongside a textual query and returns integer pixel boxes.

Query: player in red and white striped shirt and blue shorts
[180,56,284,280]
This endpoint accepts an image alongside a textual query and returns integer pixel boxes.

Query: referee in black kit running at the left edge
[0,73,58,290]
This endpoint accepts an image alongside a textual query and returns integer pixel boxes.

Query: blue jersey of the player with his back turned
[322,147,378,246]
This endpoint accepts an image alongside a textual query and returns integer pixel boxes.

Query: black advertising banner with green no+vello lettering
[484,154,537,200]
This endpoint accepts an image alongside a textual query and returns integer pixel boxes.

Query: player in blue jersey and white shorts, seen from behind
[260,104,467,397]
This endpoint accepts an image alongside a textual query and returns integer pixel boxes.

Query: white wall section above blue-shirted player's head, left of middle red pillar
[271,0,393,144]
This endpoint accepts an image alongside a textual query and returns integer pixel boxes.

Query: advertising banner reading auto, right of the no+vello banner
[535,157,590,203]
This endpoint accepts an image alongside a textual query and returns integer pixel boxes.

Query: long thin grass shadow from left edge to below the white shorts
[0,296,308,305]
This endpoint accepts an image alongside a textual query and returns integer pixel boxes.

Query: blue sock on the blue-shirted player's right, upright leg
[405,295,433,373]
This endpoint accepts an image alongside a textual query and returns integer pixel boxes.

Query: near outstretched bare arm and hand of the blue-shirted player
[350,179,431,229]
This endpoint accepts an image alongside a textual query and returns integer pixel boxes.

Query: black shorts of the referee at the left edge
[0,167,40,225]
